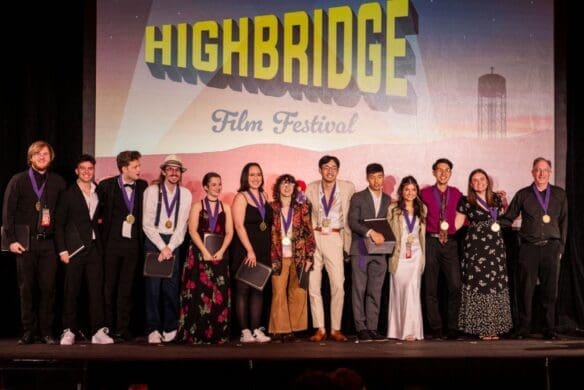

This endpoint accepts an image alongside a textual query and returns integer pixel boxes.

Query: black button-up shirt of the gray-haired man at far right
[500,184,568,253]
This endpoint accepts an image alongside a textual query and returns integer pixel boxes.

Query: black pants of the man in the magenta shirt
[424,236,462,331]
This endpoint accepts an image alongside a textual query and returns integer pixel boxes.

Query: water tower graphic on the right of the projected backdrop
[477,67,507,138]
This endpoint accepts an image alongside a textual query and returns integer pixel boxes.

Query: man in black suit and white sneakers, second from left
[55,154,114,345]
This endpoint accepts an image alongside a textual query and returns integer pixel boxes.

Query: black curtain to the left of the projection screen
[0,1,84,336]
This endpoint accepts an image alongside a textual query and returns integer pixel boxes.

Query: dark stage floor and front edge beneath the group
[0,337,584,390]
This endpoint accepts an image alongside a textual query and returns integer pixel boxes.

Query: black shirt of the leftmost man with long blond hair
[2,170,66,243]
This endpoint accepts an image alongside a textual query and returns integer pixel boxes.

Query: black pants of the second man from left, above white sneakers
[63,245,104,334]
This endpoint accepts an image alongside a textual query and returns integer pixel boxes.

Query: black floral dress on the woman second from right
[457,197,513,336]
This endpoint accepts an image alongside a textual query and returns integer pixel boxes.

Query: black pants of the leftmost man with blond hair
[16,238,58,337]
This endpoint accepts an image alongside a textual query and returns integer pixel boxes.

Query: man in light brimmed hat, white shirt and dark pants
[142,154,192,344]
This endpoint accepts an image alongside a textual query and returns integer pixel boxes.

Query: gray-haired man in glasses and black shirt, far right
[501,157,568,340]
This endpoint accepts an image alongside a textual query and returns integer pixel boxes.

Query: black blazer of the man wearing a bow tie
[96,175,148,244]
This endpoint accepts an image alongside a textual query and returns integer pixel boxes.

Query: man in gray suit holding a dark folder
[349,163,391,342]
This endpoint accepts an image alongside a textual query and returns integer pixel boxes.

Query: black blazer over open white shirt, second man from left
[55,183,102,254]
